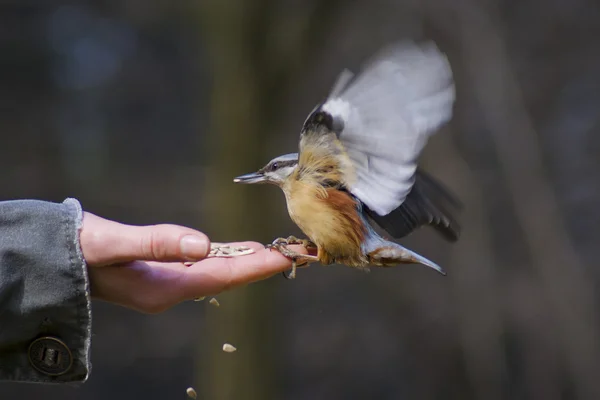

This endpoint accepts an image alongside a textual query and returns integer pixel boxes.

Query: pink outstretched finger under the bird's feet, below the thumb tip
[181,242,308,299]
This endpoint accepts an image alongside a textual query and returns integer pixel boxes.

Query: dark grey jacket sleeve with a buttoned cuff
[0,199,91,383]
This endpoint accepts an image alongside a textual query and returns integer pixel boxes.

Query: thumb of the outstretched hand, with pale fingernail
[80,212,210,266]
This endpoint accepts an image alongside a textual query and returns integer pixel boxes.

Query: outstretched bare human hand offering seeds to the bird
[79,212,306,313]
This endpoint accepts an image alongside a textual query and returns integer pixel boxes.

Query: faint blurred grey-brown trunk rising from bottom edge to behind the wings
[423,132,507,400]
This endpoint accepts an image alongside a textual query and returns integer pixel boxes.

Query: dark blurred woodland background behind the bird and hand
[0,0,600,400]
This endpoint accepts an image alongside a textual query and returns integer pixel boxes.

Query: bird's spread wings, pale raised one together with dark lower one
[300,41,458,239]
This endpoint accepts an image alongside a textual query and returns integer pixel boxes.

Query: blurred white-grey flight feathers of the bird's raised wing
[322,42,455,216]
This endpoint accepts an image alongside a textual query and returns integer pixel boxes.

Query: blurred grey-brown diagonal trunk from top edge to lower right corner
[459,2,600,399]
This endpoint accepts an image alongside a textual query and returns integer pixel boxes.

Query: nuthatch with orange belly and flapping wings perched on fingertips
[234,40,462,279]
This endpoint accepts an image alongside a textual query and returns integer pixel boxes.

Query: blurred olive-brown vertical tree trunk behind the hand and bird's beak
[188,0,342,400]
